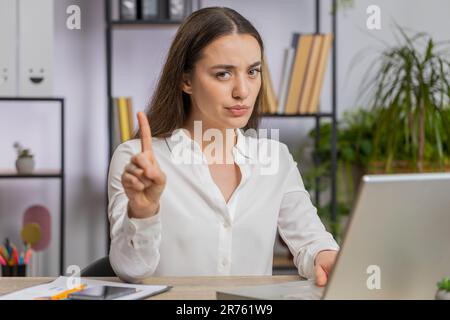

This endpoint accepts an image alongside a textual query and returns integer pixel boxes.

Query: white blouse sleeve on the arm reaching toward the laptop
[278,144,339,279]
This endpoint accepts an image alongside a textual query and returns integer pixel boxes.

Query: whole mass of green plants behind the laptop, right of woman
[302,27,450,240]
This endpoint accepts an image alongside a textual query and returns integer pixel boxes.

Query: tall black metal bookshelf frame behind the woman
[105,0,337,268]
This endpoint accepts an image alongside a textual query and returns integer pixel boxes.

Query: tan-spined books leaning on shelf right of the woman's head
[277,33,333,114]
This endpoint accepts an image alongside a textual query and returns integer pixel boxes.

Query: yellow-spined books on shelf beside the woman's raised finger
[112,97,134,149]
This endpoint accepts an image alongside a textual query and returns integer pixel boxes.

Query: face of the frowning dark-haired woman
[182,34,261,129]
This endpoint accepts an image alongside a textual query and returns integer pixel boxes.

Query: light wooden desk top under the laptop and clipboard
[0,275,302,300]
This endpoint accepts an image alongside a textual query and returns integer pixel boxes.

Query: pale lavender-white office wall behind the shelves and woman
[0,0,450,275]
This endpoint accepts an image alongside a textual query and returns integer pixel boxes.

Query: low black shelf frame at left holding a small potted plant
[0,97,65,275]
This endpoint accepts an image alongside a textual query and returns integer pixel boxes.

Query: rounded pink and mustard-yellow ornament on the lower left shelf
[21,205,51,251]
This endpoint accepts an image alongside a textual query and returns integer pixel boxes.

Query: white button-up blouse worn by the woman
[108,129,339,282]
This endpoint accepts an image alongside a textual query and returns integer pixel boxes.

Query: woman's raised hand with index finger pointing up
[122,112,166,219]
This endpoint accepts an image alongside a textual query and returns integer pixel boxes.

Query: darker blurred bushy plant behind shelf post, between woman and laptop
[294,108,377,238]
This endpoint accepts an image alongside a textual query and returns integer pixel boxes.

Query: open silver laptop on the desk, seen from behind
[217,173,450,299]
